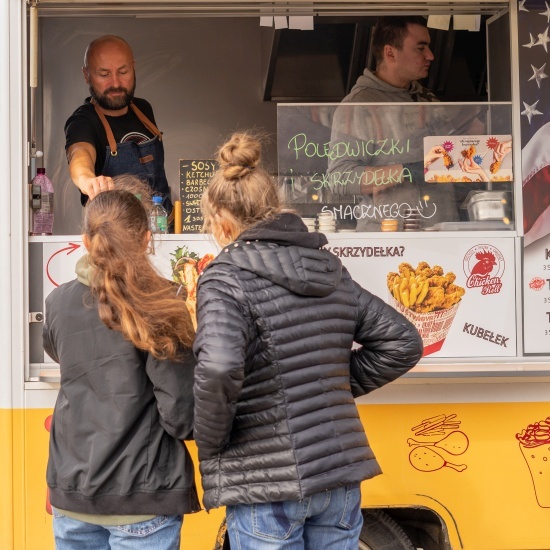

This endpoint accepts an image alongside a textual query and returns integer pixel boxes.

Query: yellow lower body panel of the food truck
[0,403,550,550]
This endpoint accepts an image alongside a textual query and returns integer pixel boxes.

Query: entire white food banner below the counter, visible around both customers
[43,233,516,358]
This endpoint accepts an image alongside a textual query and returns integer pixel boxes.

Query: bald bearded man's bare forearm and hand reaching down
[67,141,115,199]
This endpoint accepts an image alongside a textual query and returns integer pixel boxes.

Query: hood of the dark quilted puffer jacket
[203,213,342,296]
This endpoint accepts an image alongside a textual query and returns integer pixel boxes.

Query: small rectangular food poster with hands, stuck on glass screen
[424,135,513,183]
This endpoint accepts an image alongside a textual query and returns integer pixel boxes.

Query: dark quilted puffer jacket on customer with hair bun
[194,214,422,509]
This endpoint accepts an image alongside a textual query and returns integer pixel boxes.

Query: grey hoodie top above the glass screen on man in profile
[348,69,438,103]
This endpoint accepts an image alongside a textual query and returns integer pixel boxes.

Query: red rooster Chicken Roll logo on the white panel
[463,244,505,294]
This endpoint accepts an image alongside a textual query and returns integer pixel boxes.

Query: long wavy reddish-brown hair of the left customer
[83,183,194,359]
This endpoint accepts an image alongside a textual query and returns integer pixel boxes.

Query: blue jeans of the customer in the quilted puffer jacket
[227,484,363,550]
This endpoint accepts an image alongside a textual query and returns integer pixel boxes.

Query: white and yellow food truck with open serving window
[0,0,550,550]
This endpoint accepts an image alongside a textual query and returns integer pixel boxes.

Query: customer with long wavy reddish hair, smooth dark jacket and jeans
[43,176,200,550]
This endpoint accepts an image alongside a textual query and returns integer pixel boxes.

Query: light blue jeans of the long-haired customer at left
[52,509,183,550]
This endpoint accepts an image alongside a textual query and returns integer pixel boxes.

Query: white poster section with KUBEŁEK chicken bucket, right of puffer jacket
[327,234,517,358]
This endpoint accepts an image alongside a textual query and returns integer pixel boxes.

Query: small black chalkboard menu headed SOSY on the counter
[180,159,218,233]
